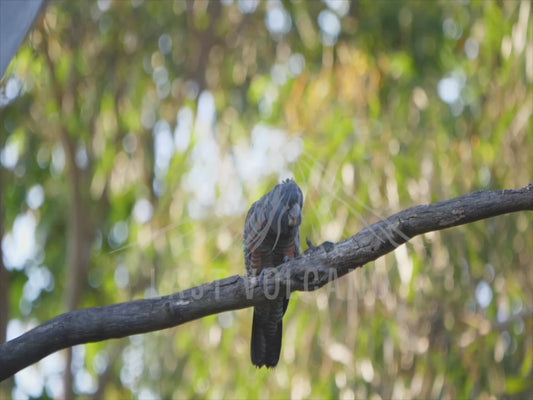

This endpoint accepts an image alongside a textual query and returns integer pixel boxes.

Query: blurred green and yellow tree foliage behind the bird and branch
[0,0,533,398]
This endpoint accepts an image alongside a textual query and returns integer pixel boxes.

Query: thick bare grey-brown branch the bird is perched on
[0,184,533,381]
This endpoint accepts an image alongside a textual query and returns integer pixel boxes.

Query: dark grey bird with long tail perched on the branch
[244,179,303,368]
